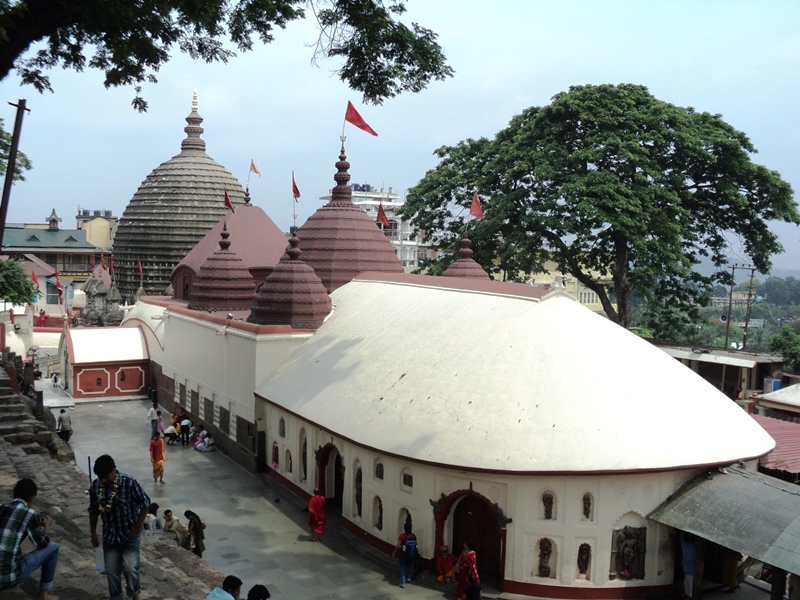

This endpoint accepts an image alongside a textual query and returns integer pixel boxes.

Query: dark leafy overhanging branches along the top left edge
[0,0,453,110]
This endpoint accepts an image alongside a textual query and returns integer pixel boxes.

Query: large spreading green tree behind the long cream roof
[403,84,800,336]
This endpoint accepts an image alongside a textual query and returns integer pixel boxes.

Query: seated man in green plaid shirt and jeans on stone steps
[0,478,58,600]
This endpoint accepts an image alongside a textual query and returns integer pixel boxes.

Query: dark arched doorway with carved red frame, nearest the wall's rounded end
[434,489,511,587]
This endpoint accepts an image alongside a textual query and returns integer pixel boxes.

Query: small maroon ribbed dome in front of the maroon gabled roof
[189,226,256,311]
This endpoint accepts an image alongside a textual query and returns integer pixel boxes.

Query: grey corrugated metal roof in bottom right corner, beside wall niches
[648,466,800,574]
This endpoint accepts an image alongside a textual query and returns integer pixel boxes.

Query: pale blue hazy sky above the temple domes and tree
[0,0,800,272]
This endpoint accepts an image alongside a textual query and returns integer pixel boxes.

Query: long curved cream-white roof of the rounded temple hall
[256,274,774,473]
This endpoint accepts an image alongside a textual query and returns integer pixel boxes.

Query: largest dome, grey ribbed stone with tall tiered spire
[114,96,244,299]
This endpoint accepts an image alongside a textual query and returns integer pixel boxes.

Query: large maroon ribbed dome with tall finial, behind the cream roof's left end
[298,146,403,293]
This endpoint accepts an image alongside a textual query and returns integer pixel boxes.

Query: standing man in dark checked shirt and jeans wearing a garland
[89,454,150,600]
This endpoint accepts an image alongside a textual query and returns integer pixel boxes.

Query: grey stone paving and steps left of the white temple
[0,384,768,600]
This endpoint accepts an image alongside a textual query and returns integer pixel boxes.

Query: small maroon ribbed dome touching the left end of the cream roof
[247,237,331,329]
